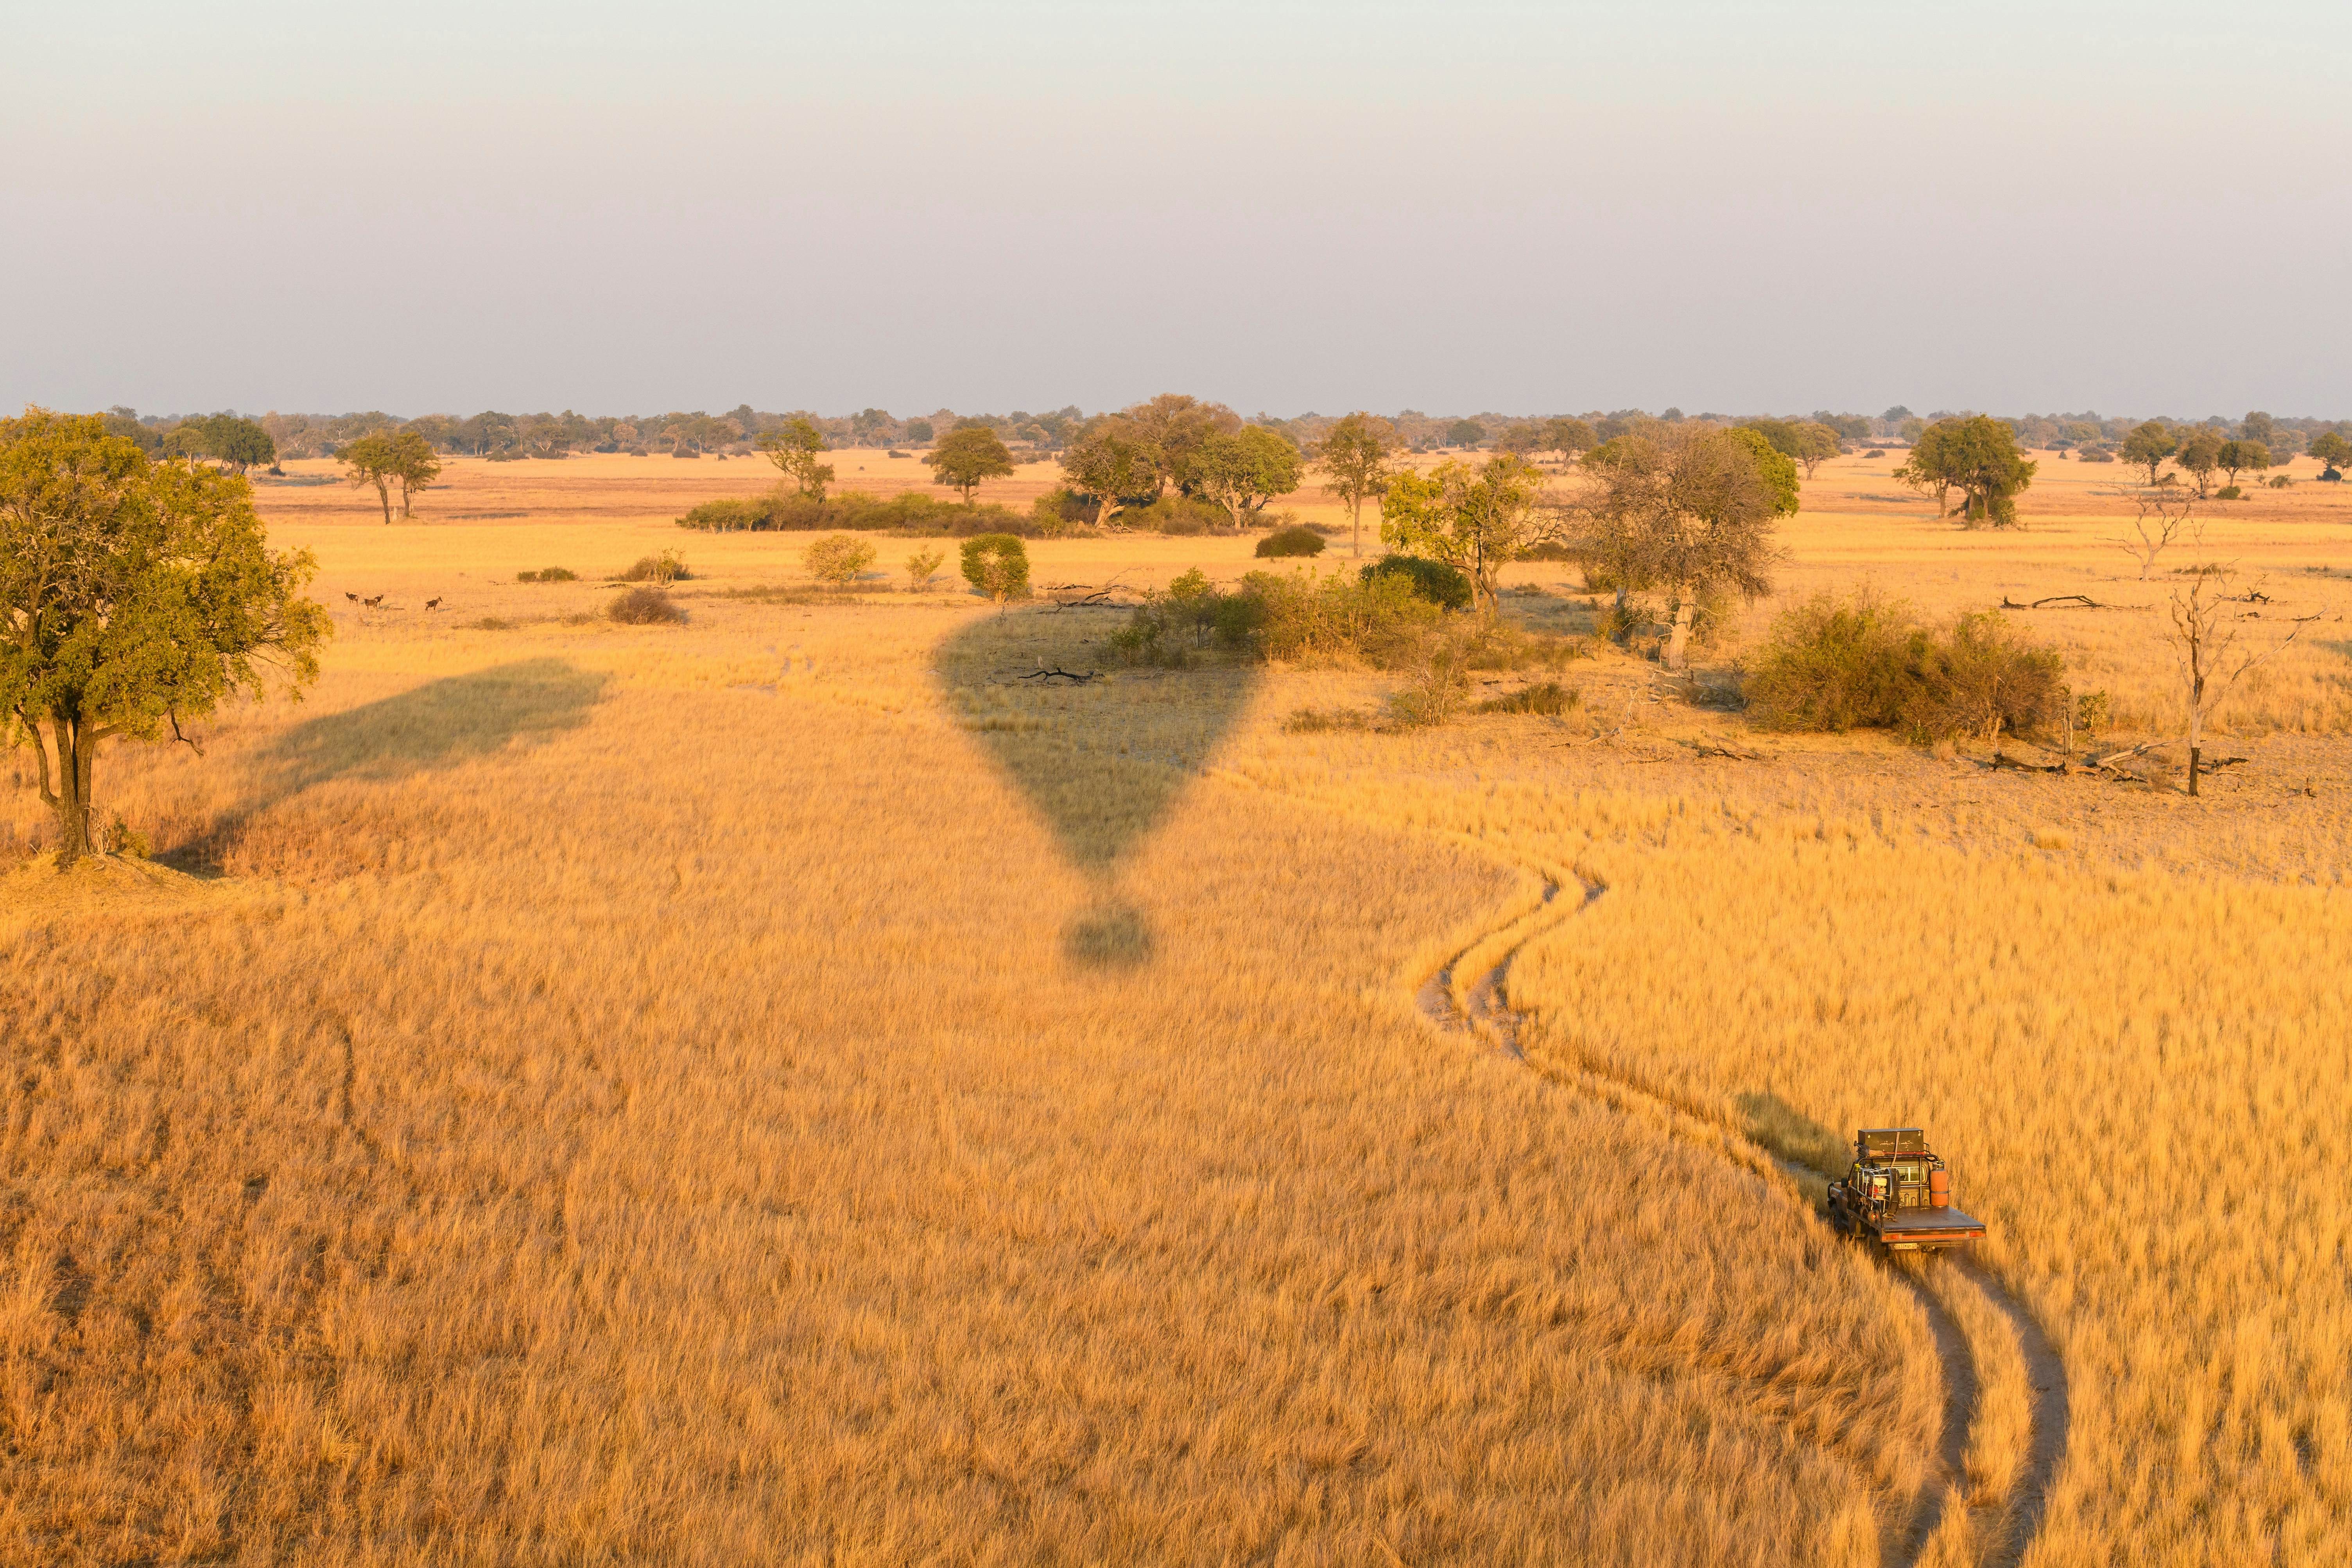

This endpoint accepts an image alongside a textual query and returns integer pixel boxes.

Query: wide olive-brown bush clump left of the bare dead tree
[1745,590,2065,740]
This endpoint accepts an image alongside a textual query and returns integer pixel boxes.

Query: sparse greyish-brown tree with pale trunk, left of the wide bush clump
[1585,423,1778,670]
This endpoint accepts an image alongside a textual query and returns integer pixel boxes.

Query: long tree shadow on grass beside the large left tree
[158,658,607,874]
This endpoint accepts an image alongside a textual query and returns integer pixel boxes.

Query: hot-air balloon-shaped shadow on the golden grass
[936,609,1256,969]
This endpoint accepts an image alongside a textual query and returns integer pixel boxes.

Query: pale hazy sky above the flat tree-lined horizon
[0,0,2352,416]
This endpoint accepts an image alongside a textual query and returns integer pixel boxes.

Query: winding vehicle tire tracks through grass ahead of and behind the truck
[1414,869,2067,1566]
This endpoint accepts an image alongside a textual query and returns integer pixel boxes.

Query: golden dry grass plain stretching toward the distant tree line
[0,452,2352,1568]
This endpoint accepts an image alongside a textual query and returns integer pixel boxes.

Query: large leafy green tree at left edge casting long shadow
[0,409,332,870]
